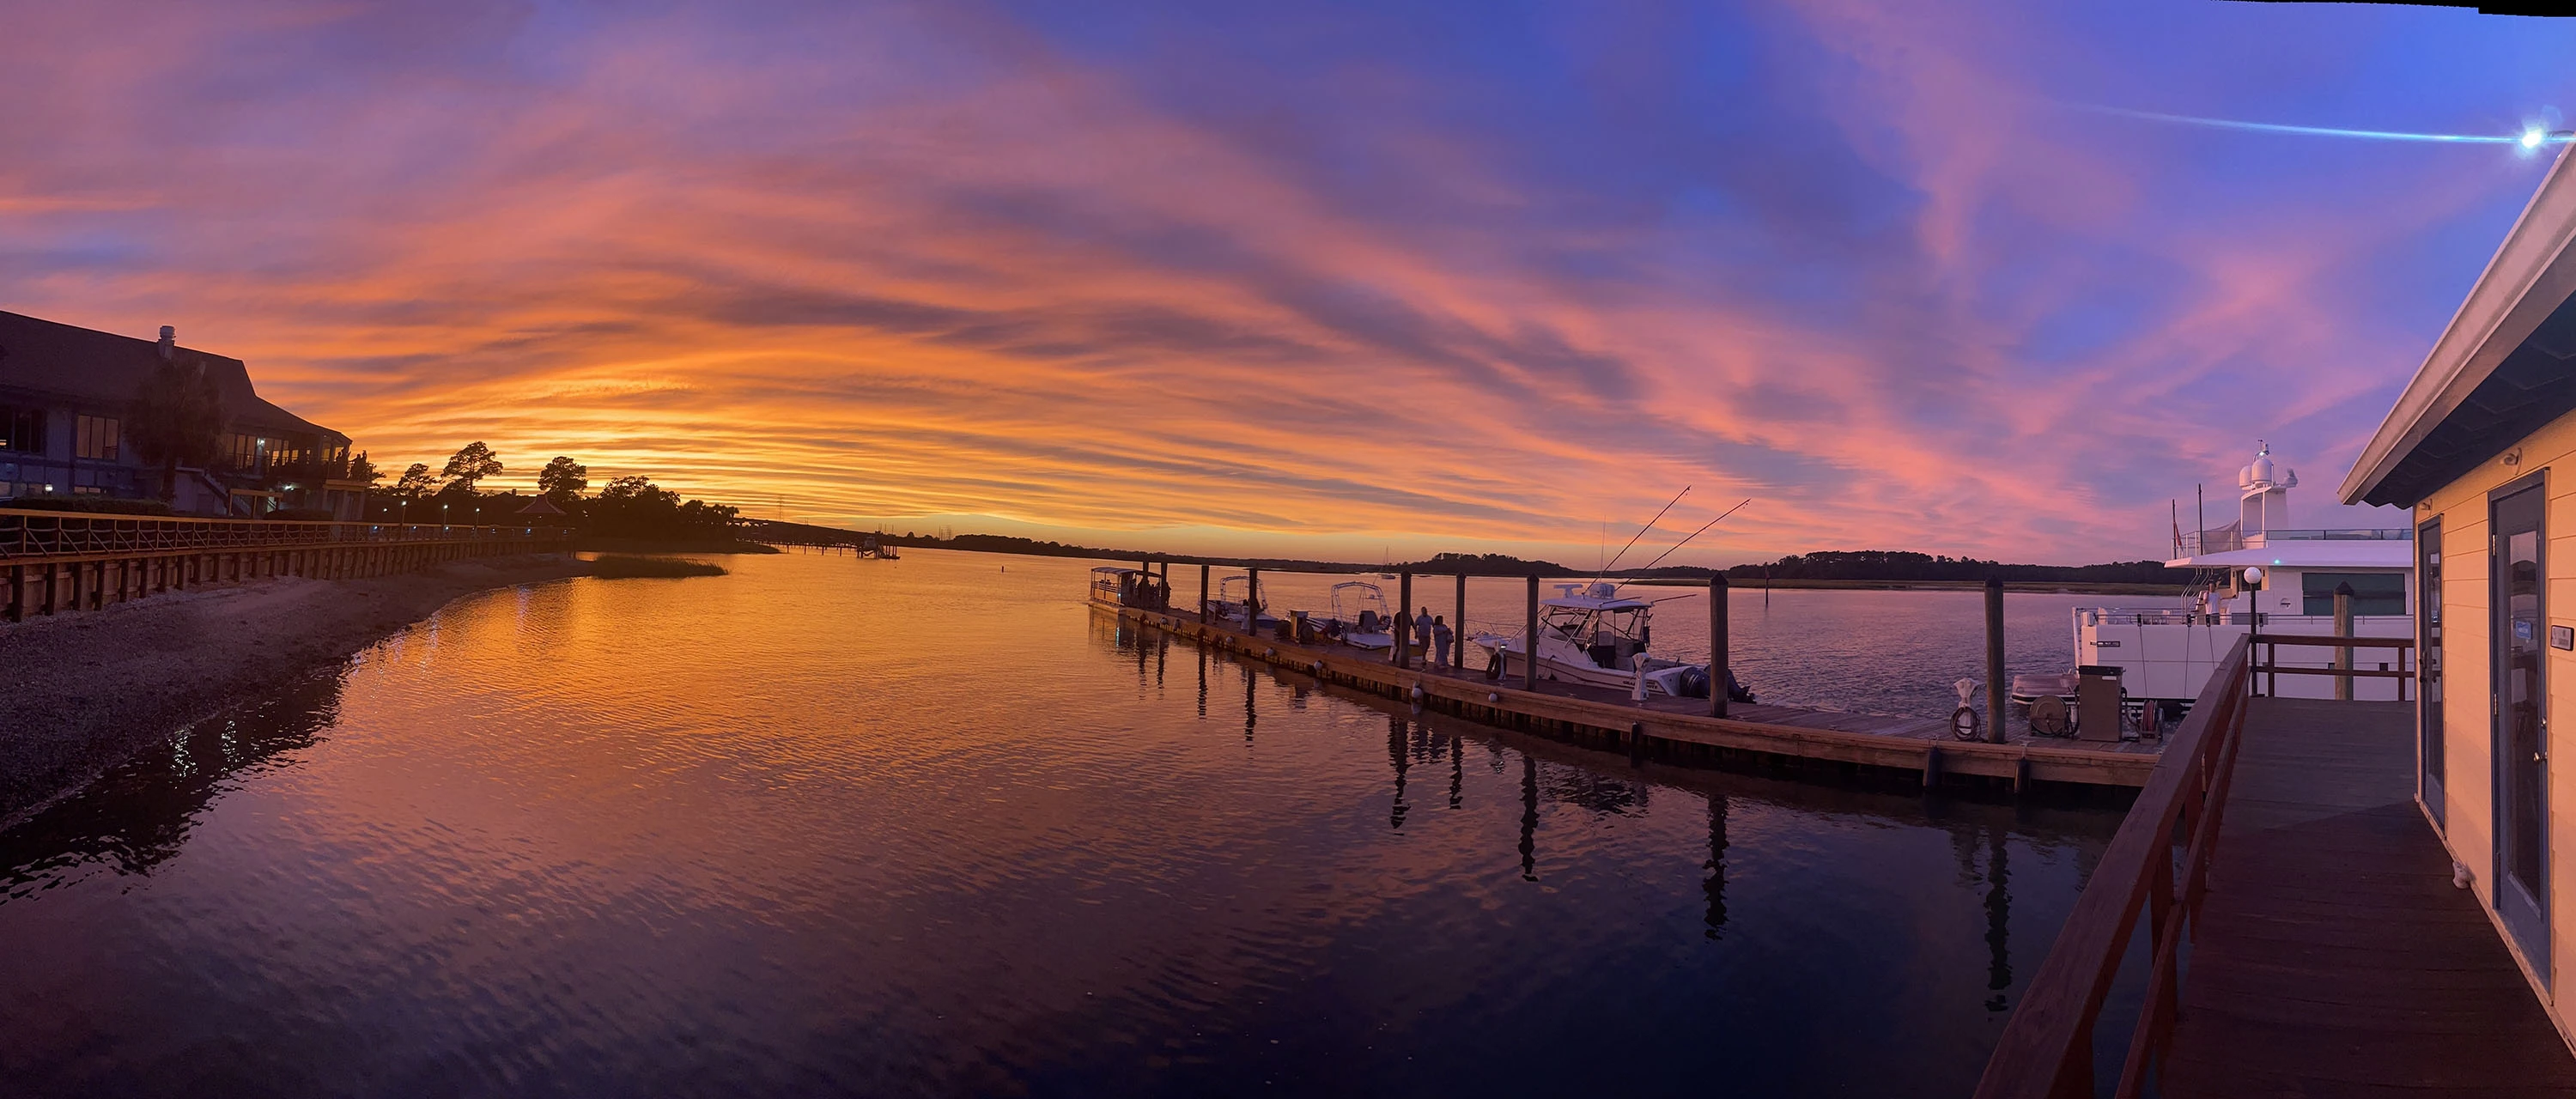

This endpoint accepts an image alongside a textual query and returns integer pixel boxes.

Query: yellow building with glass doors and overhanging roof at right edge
[2342,155,2576,1050]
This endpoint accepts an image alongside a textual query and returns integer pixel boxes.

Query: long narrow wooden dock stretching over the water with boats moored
[1118,602,2161,792]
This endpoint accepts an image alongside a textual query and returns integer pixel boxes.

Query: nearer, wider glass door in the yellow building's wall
[2488,479,2550,981]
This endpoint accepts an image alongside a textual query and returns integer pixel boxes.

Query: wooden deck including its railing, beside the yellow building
[1976,638,2576,1099]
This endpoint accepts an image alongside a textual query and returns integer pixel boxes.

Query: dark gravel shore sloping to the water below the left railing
[0,553,590,829]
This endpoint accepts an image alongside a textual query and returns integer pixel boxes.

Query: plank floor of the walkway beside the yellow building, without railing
[2164,697,2576,1099]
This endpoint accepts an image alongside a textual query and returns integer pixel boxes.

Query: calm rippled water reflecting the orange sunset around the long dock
[0,550,2117,1096]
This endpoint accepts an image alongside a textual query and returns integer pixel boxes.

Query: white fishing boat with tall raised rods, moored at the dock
[1473,579,1752,702]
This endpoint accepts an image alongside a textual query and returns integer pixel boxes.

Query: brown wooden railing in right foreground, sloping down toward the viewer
[1976,638,2254,1099]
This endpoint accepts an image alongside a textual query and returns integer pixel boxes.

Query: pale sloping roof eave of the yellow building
[2339,147,2576,505]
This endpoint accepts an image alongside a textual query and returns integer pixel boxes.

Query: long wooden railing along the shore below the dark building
[0,507,564,561]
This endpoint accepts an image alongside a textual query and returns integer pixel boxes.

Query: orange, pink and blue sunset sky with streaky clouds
[0,0,2576,563]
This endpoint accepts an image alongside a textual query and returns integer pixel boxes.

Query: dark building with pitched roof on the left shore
[0,312,366,520]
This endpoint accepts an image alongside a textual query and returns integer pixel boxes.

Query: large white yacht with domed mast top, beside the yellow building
[2050,446,2419,718]
